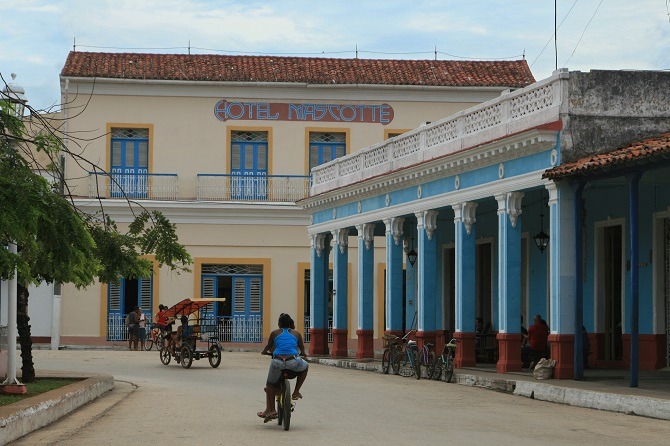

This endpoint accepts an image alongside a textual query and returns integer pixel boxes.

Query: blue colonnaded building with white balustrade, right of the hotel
[300,70,670,378]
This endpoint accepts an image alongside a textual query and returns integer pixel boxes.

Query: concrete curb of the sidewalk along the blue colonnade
[309,357,670,420]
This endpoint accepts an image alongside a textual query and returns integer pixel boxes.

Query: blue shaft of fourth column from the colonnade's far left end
[384,217,403,333]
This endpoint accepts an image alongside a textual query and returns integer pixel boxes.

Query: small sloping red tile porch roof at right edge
[542,133,670,180]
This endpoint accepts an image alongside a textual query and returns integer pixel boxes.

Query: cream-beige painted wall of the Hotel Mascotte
[62,81,498,340]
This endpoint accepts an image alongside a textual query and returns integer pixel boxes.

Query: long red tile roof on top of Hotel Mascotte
[61,51,535,88]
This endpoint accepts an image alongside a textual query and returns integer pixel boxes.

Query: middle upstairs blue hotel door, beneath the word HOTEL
[230,140,268,200]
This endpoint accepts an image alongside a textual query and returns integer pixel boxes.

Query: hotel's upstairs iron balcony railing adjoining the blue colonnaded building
[196,173,310,203]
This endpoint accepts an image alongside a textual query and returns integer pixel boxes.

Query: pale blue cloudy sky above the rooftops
[0,0,670,109]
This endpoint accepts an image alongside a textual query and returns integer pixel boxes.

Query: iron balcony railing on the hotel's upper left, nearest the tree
[88,172,179,200]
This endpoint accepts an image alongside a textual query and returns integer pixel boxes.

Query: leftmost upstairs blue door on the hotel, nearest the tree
[110,138,149,198]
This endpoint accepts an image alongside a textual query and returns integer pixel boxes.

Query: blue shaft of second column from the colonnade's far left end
[333,229,349,330]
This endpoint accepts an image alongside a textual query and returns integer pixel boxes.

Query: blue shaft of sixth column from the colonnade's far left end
[453,202,477,333]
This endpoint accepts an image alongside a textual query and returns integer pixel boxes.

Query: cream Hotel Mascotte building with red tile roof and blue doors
[22,52,534,344]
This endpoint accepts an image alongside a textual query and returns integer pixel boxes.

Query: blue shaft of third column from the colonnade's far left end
[357,224,375,330]
